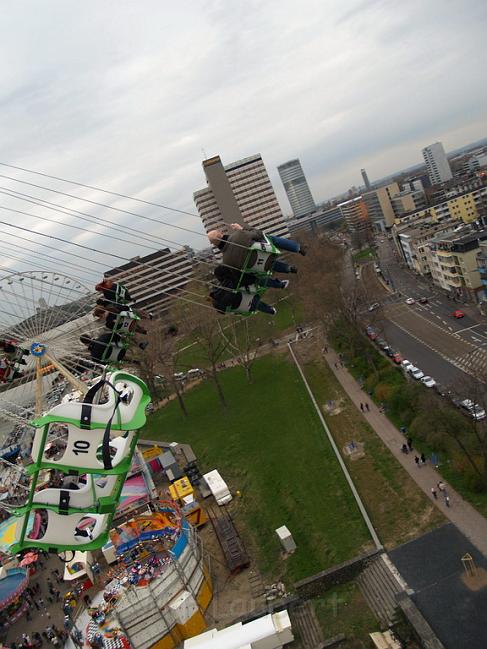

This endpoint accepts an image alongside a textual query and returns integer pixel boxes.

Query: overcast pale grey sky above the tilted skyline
[0,0,487,281]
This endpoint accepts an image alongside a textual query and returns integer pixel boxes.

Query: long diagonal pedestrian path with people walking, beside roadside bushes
[324,348,487,557]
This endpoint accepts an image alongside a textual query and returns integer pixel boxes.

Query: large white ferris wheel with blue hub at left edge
[0,271,103,434]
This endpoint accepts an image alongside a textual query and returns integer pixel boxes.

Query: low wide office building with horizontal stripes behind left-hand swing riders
[105,248,193,315]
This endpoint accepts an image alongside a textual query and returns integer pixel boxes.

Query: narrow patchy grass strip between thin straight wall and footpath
[304,360,444,548]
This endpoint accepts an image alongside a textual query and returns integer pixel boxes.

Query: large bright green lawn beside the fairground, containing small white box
[143,355,370,583]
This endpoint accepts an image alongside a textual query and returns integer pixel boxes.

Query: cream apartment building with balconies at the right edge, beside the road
[426,226,487,302]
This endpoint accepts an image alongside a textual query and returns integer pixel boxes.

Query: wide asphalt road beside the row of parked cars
[361,235,487,398]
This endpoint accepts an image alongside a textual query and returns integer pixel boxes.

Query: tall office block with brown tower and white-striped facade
[193,154,289,237]
